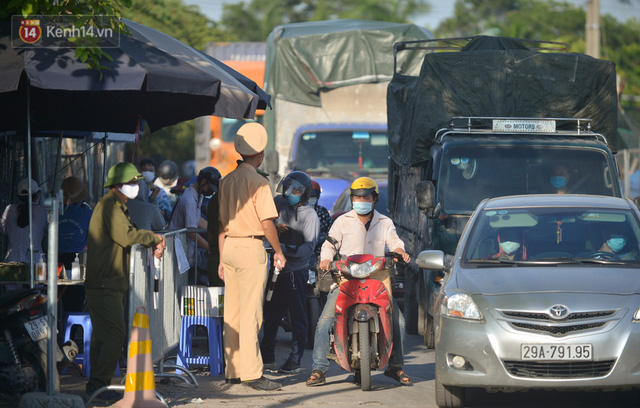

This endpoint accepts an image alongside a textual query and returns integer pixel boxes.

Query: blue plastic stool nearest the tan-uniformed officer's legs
[176,316,224,376]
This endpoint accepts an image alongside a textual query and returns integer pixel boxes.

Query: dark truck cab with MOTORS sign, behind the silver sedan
[395,117,622,346]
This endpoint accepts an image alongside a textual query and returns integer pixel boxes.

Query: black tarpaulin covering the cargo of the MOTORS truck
[387,37,618,165]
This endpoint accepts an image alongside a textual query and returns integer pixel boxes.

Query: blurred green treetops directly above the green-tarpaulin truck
[221,0,429,41]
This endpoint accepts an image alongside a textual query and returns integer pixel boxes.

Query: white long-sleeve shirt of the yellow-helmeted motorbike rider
[320,210,404,261]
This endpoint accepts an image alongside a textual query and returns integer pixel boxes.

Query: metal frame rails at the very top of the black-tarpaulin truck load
[393,36,569,74]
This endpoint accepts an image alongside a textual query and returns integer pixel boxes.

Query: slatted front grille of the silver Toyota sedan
[501,310,616,337]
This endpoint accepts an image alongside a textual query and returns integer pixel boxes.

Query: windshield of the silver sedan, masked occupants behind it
[462,207,640,267]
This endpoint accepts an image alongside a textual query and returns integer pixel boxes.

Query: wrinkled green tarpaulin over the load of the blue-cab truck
[265,20,433,109]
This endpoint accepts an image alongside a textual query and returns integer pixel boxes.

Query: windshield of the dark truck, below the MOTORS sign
[440,145,618,214]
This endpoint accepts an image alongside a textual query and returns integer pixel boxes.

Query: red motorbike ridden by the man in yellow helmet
[328,237,402,391]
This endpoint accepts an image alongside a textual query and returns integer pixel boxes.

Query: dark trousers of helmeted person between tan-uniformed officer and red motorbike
[260,268,309,364]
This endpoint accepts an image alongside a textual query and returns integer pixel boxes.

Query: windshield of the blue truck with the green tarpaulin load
[293,130,389,175]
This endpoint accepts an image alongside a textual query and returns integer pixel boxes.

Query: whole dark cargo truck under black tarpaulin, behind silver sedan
[387,36,621,347]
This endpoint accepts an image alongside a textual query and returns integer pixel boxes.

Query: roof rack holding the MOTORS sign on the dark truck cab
[434,116,608,144]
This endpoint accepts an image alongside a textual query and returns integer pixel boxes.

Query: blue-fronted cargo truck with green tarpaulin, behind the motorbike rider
[265,20,433,209]
